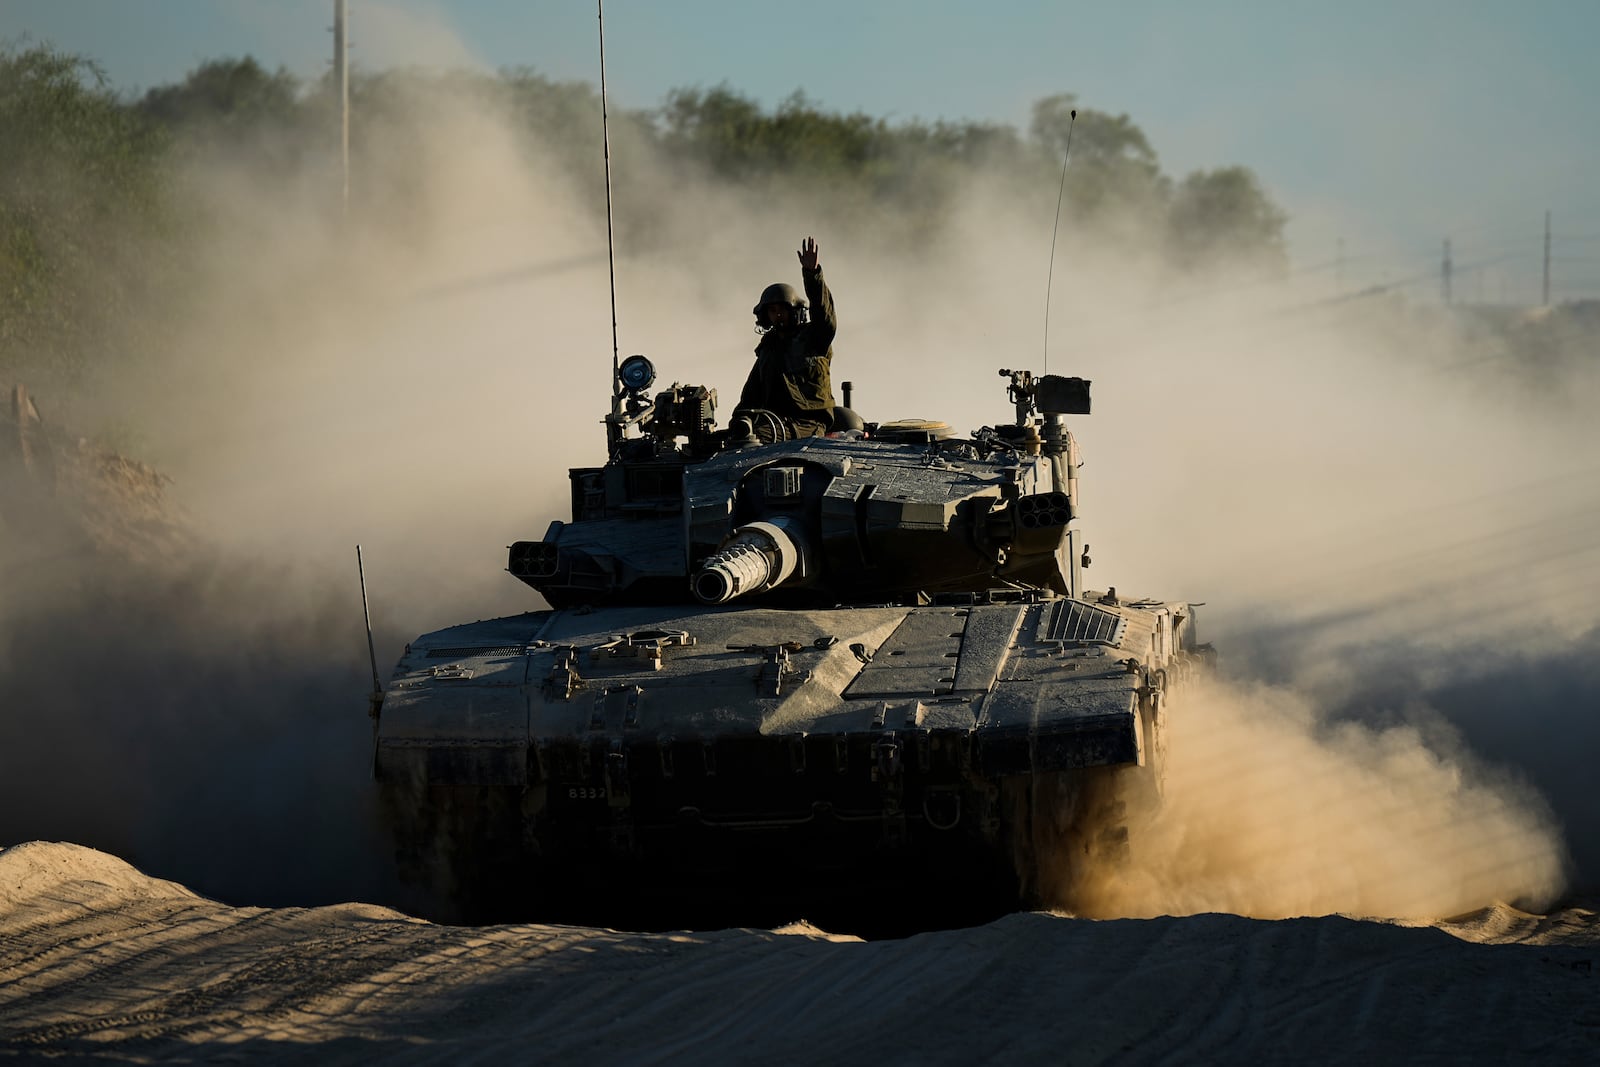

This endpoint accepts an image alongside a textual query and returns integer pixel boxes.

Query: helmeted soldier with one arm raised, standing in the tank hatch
[734,237,838,437]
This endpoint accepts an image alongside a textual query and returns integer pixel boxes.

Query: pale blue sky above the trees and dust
[0,0,1600,304]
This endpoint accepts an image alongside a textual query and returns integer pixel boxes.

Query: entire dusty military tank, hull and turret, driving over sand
[371,357,1210,933]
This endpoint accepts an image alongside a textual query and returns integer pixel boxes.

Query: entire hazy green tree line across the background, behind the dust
[0,45,1286,391]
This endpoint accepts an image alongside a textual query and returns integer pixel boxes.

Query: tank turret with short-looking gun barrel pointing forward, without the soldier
[509,357,1090,606]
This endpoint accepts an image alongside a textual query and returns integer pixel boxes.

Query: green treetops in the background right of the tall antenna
[656,85,1285,270]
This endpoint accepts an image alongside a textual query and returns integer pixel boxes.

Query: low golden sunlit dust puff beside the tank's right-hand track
[1051,681,1566,920]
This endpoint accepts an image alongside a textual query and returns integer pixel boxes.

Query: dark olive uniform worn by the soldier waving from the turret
[739,267,838,437]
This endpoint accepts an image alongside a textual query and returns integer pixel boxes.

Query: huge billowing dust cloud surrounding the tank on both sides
[0,45,1600,915]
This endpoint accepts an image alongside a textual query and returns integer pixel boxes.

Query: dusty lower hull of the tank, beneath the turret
[374,595,1197,933]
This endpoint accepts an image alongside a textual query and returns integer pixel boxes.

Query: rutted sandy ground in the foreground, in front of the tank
[0,843,1600,1064]
